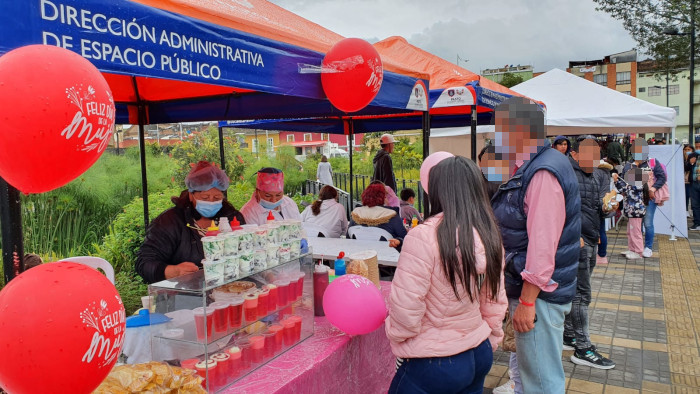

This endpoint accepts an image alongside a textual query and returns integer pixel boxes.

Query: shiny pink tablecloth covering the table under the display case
[224,282,395,394]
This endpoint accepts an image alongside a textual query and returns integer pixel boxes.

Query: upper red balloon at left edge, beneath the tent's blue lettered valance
[0,45,114,193]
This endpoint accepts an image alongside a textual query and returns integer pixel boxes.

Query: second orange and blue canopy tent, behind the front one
[227,36,544,158]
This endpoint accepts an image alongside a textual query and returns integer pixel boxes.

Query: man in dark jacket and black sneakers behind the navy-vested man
[564,137,615,369]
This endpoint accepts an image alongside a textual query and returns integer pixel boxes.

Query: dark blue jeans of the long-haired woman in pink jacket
[389,339,493,394]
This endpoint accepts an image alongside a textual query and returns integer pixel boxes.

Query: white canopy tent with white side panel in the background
[430,69,687,237]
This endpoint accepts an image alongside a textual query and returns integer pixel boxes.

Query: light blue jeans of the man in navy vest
[508,298,571,394]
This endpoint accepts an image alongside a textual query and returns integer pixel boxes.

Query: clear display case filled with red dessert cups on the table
[149,253,314,392]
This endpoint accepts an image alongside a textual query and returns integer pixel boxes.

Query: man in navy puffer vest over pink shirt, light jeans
[491,97,581,393]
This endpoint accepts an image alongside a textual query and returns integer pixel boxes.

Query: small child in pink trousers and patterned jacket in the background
[613,168,649,259]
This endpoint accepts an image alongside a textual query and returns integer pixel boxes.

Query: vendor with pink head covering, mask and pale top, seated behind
[241,167,301,225]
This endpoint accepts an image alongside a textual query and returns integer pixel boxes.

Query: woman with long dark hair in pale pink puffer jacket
[386,152,508,393]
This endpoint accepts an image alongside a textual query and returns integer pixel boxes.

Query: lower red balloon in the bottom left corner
[0,262,126,393]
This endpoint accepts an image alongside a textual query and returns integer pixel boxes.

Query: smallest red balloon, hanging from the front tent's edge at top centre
[321,38,384,112]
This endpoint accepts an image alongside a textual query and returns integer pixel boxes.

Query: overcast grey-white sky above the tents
[271,0,641,73]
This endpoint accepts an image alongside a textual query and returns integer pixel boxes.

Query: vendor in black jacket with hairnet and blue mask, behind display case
[136,161,245,283]
